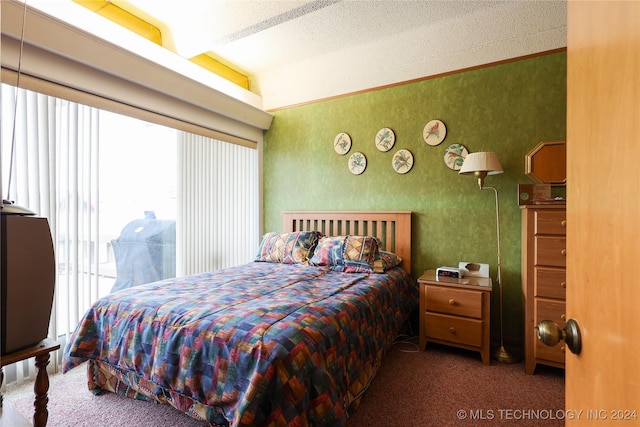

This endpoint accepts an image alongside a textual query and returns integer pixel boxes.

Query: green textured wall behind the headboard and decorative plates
[263,51,566,341]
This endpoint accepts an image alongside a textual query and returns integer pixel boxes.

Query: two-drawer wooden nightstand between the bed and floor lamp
[418,270,492,365]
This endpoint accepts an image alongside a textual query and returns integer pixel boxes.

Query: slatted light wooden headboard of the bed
[282,211,411,274]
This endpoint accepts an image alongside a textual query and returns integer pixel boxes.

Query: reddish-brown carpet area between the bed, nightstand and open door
[347,343,565,427]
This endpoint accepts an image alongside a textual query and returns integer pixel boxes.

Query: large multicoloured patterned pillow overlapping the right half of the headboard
[309,235,380,273]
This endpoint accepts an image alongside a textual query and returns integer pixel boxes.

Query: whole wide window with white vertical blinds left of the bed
[2,81,259,354]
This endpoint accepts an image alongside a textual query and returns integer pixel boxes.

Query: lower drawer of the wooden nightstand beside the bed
[425,312,482,347]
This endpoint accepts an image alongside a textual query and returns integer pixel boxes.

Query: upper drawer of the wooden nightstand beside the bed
[424,286,482,319]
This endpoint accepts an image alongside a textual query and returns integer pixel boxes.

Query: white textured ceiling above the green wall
[46,0,566,109]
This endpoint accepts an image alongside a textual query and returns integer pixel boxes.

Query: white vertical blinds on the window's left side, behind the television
[1,85,99,382]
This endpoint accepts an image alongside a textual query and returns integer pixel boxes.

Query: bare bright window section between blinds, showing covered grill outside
[96,111,178,296]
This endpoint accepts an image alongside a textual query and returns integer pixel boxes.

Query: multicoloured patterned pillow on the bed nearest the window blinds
[255,231,322,264]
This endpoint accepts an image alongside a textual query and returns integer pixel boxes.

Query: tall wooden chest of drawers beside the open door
[521,204,567,374]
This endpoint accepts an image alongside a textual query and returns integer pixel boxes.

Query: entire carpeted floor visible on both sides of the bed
[5,343,564,427]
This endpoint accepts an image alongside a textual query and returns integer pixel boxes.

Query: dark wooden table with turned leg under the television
[0,338,60,427]
